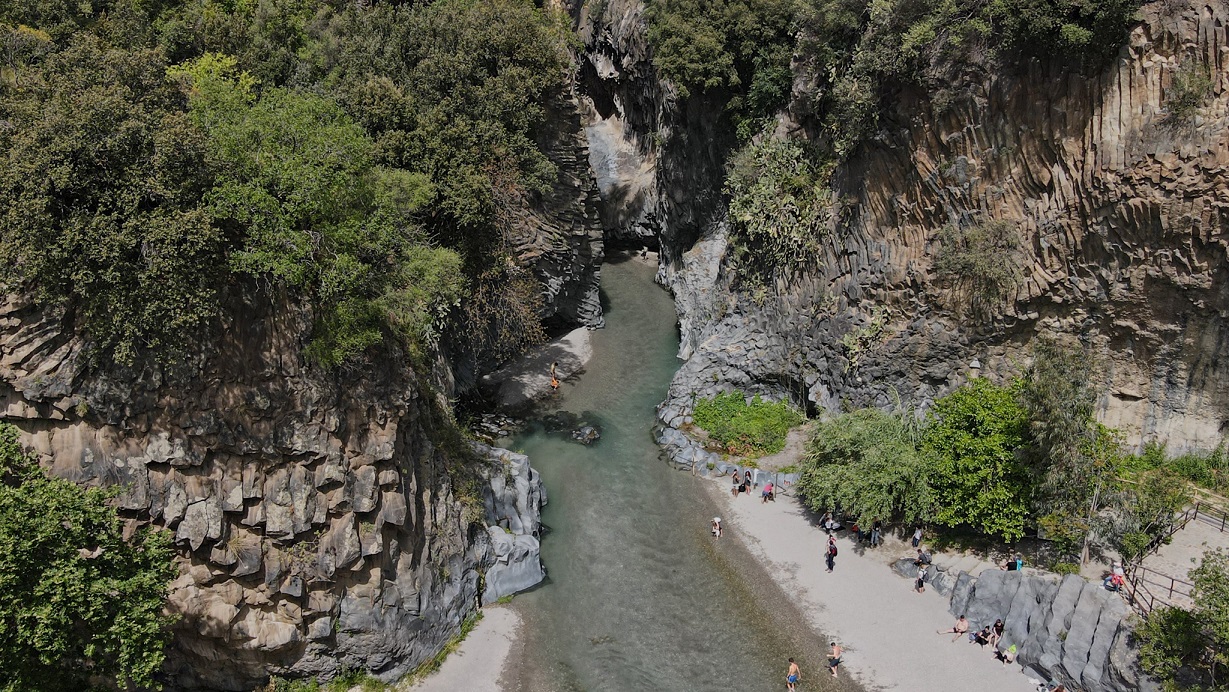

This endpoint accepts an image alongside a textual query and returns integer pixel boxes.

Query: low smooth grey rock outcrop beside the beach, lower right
[943,560,1160,692]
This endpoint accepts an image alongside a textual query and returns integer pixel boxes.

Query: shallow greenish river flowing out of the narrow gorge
[504,261,815,692]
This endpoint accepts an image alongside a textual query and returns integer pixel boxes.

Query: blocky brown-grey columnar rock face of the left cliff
[0,299,544,690]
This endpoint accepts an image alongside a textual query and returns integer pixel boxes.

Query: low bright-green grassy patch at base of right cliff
[692,392,806,457]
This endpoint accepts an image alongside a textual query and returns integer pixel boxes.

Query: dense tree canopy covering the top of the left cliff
[0,0,571,366]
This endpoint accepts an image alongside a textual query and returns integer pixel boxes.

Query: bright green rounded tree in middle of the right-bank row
[923,379,1032,542]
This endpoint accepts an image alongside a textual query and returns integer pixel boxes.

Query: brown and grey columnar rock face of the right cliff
[659,1,1229,450]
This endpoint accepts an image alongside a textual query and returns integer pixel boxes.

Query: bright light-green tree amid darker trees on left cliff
[175,54,463,366]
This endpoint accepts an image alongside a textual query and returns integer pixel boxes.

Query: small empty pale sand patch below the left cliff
[409,606,521,692]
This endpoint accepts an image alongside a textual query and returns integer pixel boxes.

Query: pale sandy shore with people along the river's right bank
[703,481,1035,692]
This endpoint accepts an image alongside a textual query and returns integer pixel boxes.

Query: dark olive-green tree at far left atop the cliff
[0,34,225,363]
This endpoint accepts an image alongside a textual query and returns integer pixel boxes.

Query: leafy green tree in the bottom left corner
[0,424,176,692]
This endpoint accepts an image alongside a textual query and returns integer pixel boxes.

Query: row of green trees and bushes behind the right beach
[799,340,1189,555]
